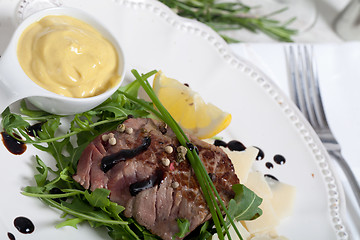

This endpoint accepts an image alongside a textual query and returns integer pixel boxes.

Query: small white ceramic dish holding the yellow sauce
[0,8,125,115]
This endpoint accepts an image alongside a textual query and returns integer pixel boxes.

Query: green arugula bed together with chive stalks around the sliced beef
[2,70,262,240]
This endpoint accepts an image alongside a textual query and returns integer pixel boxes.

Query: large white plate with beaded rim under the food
[0,0,349,240]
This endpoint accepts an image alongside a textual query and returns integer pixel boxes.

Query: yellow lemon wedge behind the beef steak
[153,71,231,139]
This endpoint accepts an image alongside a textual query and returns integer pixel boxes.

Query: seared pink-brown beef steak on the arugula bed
[74,118,239,240]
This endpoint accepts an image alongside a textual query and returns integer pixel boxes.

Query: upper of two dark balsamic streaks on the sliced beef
[101,137,151,172]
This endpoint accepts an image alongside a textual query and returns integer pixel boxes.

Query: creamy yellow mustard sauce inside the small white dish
[17,15,120,98]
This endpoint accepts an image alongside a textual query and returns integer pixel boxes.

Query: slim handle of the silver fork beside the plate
[329,151,360,207]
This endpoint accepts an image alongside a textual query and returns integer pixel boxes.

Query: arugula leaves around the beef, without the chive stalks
[2,75,261,240]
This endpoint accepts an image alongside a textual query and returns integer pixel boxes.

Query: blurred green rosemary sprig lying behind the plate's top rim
[159,0,297,43]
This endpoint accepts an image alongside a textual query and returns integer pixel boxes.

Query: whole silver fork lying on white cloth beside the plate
[285,45,360,207]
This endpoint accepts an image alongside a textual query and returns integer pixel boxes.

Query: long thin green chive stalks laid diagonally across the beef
[131,70,242,240]
